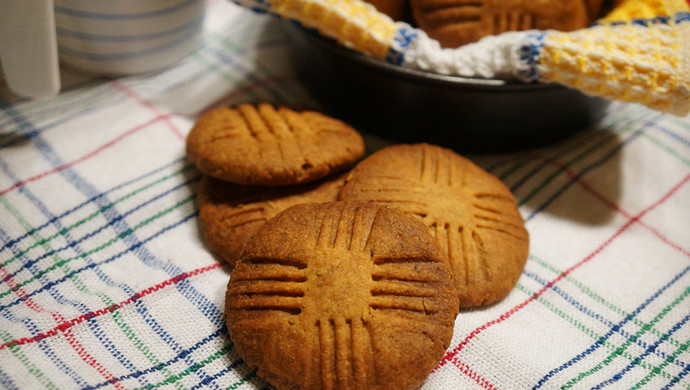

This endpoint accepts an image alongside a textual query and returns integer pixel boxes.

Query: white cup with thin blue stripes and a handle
[0,0,205,98]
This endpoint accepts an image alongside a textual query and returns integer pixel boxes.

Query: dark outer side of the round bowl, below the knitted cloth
[282,22,609,153]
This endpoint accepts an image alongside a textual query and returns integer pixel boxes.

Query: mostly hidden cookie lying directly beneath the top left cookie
[197,173,345,265]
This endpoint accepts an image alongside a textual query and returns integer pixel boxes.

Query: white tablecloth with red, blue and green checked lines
[0,0,690,389]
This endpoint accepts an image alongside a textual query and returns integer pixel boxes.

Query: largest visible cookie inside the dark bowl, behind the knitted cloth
[410,0,589,48]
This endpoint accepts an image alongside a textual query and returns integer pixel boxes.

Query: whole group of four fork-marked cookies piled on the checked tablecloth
[187,104,528,389]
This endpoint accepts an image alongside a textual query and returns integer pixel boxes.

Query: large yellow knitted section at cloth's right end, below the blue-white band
[539,22,690,115]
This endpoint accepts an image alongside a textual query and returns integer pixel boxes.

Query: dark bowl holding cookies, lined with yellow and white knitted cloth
[232,0,690,153]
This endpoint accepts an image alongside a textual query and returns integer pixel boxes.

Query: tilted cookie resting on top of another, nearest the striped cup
[187,103,364,185]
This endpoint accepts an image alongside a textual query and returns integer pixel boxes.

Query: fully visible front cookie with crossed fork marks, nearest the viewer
[225,202,458,390]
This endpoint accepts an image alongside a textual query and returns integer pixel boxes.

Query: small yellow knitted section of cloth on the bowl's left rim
[272,0,397,59]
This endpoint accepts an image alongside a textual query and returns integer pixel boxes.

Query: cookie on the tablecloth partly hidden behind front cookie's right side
[340,144,529,307]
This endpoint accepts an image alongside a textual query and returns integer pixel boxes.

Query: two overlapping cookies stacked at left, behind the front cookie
[187,104,365,265]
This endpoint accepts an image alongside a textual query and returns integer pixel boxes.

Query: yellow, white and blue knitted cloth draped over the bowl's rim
[232,0,690,116]
